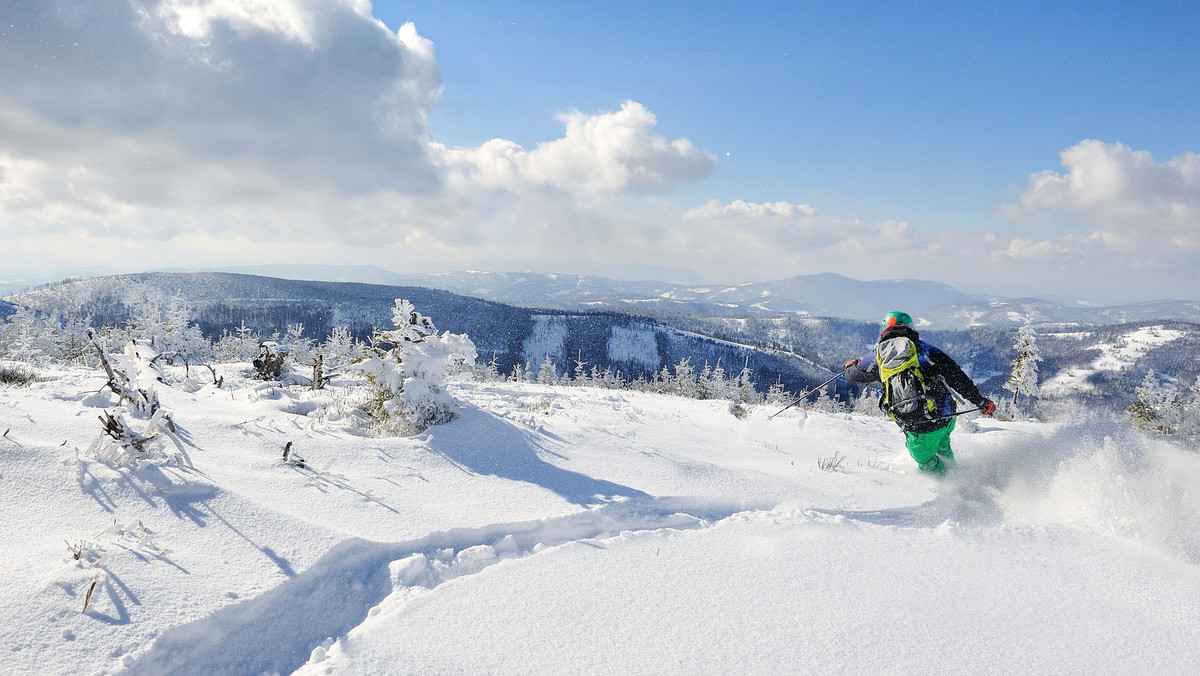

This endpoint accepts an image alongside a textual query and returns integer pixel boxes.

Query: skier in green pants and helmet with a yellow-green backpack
[844,312,996,474]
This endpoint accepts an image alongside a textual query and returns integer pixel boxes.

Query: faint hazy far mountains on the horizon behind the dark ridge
[154,265,1200,329]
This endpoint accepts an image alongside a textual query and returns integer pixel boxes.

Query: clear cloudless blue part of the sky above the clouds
[388,1,1200,225]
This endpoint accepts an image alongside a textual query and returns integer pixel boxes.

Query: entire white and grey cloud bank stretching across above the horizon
[0,0,1200,297]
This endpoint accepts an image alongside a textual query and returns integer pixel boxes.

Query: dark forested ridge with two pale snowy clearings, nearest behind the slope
[10,273,828,390]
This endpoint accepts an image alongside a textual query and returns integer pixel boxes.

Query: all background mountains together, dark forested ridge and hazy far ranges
[0,269,1200,407]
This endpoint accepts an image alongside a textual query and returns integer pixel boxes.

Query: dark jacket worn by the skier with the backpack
[844,327,988,433]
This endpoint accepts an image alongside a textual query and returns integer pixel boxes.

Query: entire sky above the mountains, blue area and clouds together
[0,0,1200,303]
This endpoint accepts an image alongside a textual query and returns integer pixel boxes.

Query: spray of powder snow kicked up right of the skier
[948,415,1200,563]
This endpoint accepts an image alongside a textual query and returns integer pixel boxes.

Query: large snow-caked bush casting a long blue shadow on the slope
[350,299,475,436]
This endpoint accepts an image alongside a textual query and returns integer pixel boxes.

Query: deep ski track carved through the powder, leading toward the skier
[130,498,745,675]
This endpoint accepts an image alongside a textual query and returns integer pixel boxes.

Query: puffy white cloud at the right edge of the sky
[1001,140,1200,250]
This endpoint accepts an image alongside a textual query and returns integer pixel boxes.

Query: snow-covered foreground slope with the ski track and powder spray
[0,369,1200,674]
